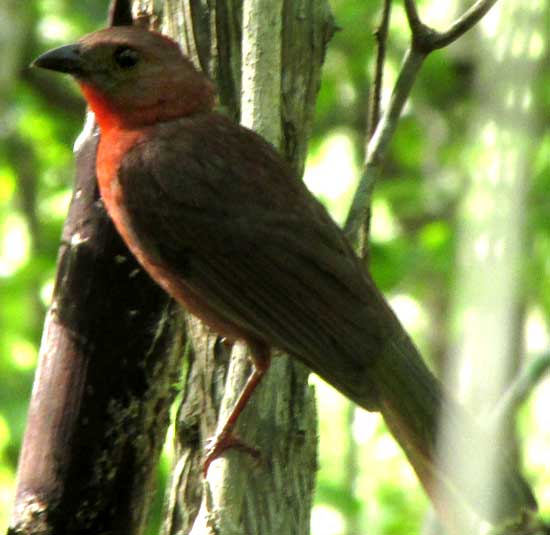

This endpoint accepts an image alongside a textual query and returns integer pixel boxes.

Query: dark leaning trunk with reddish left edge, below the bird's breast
[9,2,183,535]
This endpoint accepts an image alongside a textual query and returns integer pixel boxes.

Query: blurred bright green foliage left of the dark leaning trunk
[0,1,104,531]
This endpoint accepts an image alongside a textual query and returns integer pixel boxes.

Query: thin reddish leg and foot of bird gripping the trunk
[202,343,271,477]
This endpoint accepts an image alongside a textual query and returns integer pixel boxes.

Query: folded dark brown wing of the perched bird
[119,114,388,382]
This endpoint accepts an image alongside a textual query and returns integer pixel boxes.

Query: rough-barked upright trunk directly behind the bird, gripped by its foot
[160,0,333,535]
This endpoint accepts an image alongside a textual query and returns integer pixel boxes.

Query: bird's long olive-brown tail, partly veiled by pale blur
[368,314,537,522]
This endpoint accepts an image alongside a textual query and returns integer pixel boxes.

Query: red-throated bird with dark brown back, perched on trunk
[33,26,536,520]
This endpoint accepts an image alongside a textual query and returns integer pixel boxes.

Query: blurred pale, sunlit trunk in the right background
[441,0,544,533]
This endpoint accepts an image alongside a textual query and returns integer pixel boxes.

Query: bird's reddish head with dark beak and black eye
[32,26,218,129]
